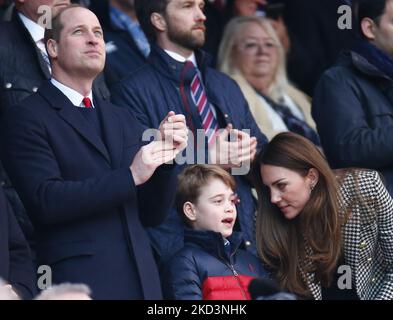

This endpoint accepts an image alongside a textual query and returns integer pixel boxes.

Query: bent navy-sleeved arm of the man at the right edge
[312,68,393,168]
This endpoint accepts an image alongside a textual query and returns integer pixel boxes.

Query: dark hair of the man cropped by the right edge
[354,0,391,37]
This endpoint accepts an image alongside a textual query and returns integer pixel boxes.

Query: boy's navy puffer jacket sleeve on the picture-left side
[163,253,203,300]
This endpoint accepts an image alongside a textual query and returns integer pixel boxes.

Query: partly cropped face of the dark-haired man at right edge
[372,0,393,57]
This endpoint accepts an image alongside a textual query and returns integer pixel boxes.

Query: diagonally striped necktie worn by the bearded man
[185,61,218,144]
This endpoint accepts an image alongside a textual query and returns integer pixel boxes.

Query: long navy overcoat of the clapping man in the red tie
[1,83,176,299]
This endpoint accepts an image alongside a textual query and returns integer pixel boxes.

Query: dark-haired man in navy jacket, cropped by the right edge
[312,0,393,195]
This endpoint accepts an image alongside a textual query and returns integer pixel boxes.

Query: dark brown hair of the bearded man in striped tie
[135,0,171,43]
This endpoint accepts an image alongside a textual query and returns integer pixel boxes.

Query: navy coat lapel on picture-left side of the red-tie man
[38,81,110,164]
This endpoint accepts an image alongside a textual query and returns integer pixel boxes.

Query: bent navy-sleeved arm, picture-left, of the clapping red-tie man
[1,106,136,225]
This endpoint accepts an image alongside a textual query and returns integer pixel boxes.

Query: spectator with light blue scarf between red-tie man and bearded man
[89,0,150,88]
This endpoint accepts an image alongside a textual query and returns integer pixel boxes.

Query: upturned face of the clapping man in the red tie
[48,8,105,79]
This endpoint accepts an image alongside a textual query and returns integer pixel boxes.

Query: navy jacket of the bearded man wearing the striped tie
[111,45,267,260]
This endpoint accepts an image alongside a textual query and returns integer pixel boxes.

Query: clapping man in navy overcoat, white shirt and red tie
[1,6,187,299]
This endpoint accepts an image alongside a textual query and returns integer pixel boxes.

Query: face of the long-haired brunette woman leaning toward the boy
[261,164,318,220]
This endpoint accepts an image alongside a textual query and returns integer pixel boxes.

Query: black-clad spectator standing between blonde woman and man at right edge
[269,0,355,96]
